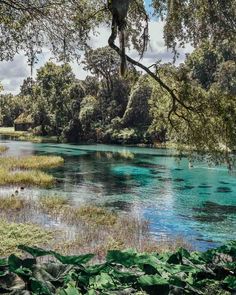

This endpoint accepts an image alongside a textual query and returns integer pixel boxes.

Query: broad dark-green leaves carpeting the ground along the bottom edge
[0,242,236,295]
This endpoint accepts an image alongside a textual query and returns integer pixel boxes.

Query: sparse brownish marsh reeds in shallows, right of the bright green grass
[39,196,191,260]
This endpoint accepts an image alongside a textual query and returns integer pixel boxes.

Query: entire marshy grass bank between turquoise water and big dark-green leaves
[0,192,191,260]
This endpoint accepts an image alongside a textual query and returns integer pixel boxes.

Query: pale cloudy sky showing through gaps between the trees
[0,0,192,94]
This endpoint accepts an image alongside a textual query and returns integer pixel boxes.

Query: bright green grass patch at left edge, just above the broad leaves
[0,219,53,257]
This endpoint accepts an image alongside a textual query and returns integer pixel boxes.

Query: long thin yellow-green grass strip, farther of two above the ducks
[0,156,64,170]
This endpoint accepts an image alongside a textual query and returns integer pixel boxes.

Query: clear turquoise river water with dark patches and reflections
[2,140,236,250]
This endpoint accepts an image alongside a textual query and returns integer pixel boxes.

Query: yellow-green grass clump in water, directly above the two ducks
[0,168,55,187]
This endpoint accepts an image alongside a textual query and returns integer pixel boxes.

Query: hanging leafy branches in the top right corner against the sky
[152,0,236,49]
